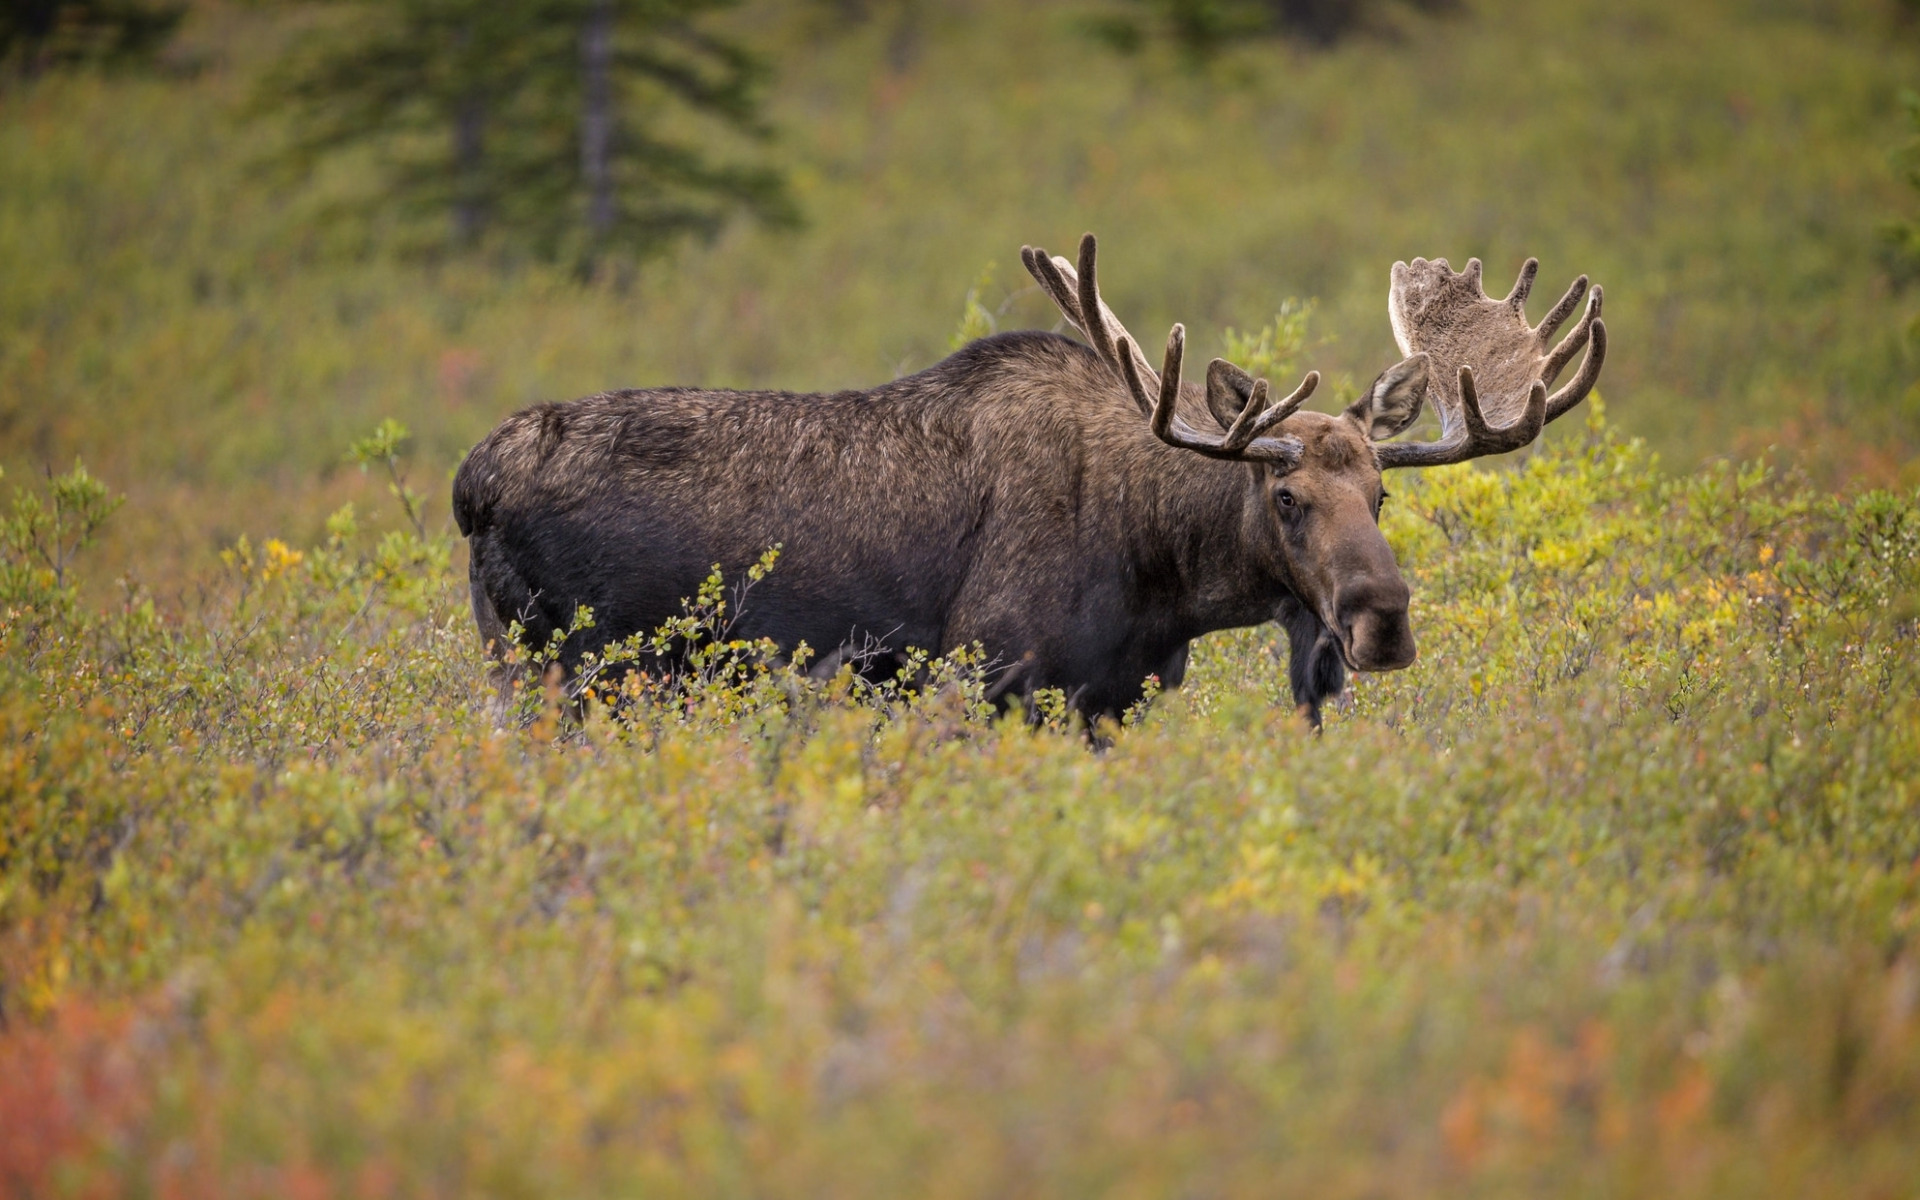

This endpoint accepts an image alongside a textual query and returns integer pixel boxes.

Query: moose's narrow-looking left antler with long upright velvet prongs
[1020,234,1319,463]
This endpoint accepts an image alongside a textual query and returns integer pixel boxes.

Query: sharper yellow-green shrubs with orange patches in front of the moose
[0,397,1920,1196]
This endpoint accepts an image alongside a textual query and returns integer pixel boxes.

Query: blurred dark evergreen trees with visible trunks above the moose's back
[259,0,797,263]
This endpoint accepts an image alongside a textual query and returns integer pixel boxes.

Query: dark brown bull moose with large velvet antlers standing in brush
[453,234,1607,728]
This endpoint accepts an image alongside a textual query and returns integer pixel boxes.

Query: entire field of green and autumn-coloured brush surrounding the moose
[0,0,1920,1198]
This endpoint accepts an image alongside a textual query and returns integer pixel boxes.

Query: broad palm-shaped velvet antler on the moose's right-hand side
[1373,259,1607,468]
